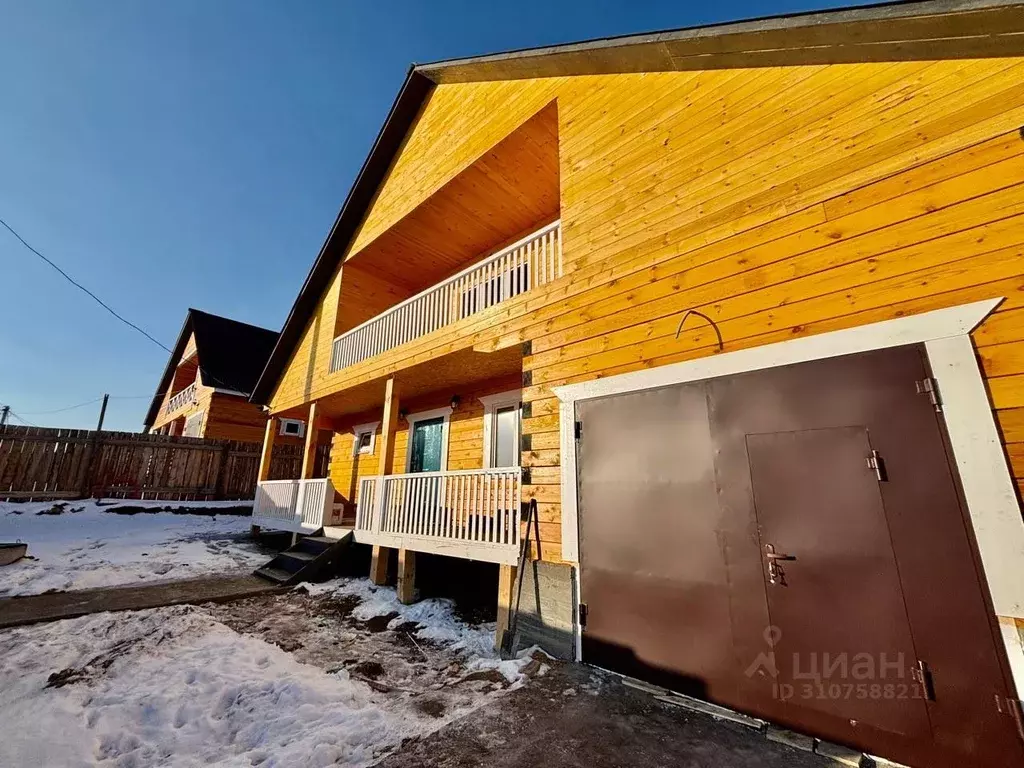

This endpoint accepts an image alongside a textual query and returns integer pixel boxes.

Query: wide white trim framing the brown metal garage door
[554,298,1024,671]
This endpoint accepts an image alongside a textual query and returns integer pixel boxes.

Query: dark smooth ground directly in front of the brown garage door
[378,664,836,768]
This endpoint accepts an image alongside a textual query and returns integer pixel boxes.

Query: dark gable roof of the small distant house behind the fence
[145,309,279,429]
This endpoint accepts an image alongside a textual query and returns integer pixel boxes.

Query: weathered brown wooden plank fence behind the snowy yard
[0,426,331,501]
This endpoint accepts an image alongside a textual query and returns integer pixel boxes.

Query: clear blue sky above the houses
[0,0,856,430]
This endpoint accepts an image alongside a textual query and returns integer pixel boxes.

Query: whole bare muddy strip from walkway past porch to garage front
[205,592,835,768]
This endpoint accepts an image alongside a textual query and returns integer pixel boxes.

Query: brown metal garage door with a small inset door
[578,347,1024,766]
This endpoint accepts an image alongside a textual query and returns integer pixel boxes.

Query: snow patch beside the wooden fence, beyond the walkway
[0,500,267,597]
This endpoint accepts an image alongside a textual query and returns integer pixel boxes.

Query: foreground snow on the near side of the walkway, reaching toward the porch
[0,582,537,768]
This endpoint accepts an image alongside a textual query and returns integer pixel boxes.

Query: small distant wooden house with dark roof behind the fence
[144,309,305,443]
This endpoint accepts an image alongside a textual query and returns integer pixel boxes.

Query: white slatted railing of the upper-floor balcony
[331,221,562,372]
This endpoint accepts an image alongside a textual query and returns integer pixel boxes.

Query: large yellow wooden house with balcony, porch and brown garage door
[247,2,1024,766]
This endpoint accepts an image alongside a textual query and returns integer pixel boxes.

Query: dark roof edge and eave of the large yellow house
[252,0,1024,402]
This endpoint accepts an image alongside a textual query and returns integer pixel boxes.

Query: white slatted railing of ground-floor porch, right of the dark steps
[355,467,522,564]
